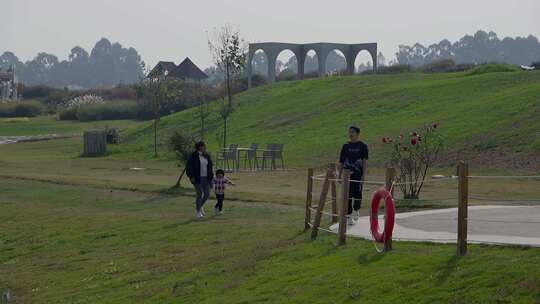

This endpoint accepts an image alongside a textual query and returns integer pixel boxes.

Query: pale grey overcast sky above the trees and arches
[4,0,540,67]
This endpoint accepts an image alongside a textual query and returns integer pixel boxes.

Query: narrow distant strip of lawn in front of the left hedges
[0,116,142,136]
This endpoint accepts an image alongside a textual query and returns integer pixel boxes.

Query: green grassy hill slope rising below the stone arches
[124,68,540,169]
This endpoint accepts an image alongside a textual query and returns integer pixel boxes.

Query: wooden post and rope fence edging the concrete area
[305,162,540,255]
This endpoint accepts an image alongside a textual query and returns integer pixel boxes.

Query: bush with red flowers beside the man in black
[382,123,443,199]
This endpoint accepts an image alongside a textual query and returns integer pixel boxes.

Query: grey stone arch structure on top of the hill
[246,42,377,88]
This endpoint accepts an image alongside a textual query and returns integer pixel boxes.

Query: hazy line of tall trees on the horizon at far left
[0,38,144,88]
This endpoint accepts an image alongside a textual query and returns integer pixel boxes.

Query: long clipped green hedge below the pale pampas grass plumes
[58,100,139,121]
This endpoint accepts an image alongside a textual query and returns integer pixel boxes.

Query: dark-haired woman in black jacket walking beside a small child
[186,141,214,218]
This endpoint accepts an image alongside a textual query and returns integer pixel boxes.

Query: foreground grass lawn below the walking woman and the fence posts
[0,178,540,303]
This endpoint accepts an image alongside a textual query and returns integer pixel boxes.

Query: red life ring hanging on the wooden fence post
[370,188,396,243]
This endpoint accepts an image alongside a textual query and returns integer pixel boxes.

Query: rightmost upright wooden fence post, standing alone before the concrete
[457,162,469,256]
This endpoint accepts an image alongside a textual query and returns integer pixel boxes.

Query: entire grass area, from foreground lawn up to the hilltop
[0,72,540,304]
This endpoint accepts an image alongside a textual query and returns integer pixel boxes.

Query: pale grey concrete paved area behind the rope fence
[330,206,540,247]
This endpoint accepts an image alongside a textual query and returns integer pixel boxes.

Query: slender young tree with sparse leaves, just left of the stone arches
[208,25,246,148]
